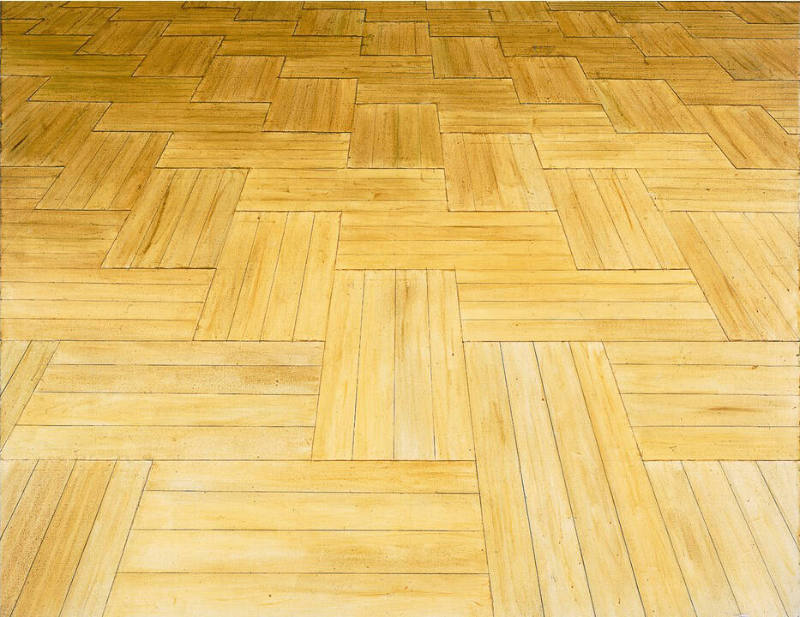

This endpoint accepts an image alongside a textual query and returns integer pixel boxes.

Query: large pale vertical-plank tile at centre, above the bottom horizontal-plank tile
[314,270,472,460]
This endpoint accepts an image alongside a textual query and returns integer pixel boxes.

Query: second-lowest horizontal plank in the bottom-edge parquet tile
[119,529,486,574]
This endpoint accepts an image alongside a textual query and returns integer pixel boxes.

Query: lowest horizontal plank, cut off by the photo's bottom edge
[106,572,492,617]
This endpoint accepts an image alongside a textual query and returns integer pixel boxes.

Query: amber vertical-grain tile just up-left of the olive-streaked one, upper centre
[264,79,358,133]
